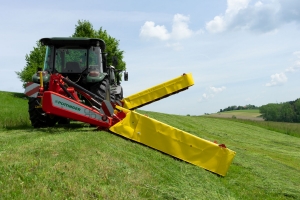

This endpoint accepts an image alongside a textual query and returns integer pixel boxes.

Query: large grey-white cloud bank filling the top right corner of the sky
[206,0,300,33]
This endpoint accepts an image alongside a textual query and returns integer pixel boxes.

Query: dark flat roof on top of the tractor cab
[40,37,105,51]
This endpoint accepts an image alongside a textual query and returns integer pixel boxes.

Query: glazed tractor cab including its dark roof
[40,38,107,84]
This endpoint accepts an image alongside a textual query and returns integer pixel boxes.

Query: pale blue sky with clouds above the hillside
[0,0,300,115]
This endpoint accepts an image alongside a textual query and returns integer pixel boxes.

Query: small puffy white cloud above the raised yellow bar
[140,14,202,40]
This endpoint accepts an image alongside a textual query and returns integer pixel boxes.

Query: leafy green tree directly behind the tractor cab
[16,20,126,87]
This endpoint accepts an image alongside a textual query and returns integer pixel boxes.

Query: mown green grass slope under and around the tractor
[0,92,300,199]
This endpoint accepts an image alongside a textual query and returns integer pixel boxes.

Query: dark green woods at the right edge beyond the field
[259,99,300,123]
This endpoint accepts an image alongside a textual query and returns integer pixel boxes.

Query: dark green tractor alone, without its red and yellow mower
[28,37,128,128]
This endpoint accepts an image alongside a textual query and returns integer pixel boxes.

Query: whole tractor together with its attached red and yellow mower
[25,38,235,176]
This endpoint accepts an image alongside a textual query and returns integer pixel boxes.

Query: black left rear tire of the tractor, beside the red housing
[28,97,57,128]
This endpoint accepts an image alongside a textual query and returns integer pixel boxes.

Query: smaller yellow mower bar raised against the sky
[122,73,194,110]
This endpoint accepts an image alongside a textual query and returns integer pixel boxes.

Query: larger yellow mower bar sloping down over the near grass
[109,106,235,176]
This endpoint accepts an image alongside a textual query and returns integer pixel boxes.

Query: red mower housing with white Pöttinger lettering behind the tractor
[39,74,126,128]
